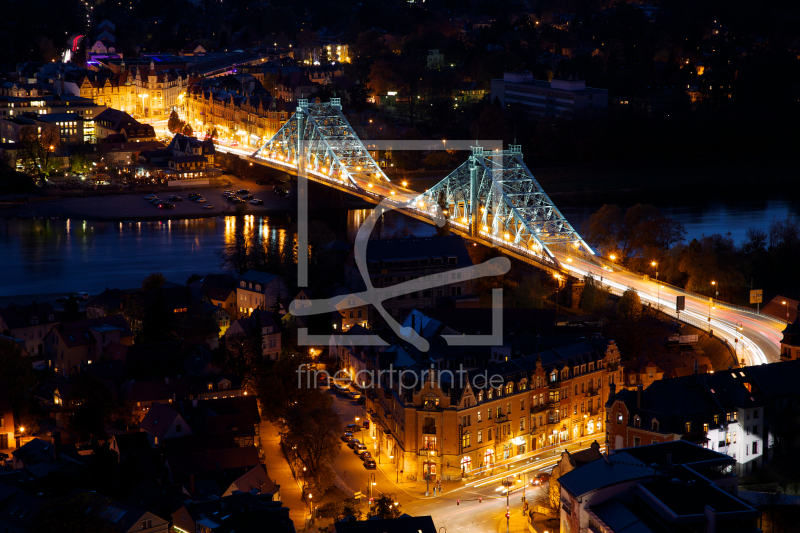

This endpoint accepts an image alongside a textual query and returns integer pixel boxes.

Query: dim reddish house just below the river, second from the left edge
[43,315,133,376]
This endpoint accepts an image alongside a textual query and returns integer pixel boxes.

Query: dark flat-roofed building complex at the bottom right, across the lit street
[558,441,761,533]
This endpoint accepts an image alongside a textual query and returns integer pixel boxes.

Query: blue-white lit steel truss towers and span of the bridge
[252,98,594,270]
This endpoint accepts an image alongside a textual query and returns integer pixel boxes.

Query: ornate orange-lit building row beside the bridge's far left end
[185,83,291,147]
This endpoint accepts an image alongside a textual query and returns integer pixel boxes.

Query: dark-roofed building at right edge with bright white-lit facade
[606,360,800,474]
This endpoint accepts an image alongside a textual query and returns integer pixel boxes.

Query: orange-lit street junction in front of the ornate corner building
[329,384,596,533]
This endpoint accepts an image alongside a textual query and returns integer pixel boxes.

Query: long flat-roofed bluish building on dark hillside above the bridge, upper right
[490,71,608,120]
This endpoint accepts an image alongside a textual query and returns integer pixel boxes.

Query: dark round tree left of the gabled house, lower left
[61,372,118,439]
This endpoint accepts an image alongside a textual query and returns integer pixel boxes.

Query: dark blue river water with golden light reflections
[0,199,800,296]
